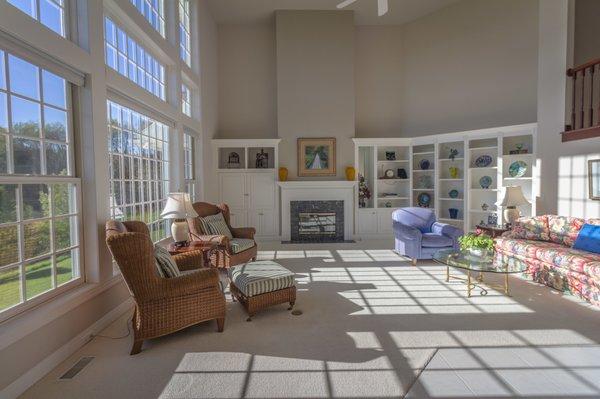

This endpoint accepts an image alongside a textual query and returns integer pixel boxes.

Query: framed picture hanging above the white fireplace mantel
[298,137,335,176]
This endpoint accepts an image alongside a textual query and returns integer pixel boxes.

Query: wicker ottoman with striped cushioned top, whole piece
[228,260,296,321]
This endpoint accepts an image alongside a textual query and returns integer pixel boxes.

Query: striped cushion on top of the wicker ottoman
[228,260,296,297]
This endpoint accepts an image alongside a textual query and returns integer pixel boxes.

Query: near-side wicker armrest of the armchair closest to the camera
[157,268,220,300]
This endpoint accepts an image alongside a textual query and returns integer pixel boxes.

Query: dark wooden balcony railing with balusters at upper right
[562,58,600,141]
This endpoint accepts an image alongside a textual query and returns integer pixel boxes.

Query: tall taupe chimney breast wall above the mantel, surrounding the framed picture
[275,11,355,179]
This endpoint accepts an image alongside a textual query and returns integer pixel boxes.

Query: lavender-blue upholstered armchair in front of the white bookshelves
[392,208,463,265]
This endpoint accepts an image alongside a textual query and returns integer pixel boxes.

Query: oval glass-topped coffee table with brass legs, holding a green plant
[433,249,527,298]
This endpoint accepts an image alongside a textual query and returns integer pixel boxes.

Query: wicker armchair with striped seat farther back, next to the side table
[188,202,258,268]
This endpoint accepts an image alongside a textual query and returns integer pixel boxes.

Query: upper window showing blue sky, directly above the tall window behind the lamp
[104,17,165,100]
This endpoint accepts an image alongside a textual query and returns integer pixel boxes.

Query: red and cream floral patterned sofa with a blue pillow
[495,215,600,306]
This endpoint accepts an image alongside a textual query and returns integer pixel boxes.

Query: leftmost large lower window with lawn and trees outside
[0,50,80,312]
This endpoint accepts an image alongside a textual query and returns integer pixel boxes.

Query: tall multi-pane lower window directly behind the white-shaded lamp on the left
[107,101,169,242]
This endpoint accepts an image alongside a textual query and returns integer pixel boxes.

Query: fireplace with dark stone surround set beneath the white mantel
[290,201,344,242]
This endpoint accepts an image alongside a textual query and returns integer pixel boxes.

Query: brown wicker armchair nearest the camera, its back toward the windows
[106,220,225,355]
